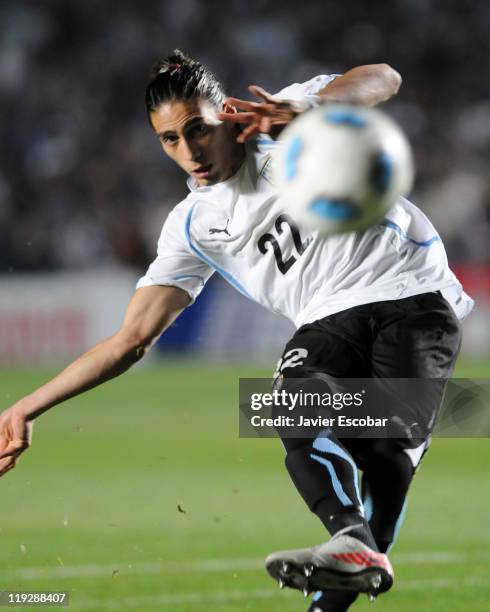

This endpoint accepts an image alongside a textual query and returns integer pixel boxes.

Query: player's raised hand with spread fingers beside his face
[217,85,301,142]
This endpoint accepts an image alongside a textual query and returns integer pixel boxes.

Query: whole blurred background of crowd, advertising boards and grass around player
[0,0,490,611]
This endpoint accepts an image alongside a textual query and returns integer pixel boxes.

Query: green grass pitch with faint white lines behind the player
[0,362,490,612]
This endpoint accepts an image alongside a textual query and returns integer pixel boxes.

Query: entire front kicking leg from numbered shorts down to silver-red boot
[266,325,392,592]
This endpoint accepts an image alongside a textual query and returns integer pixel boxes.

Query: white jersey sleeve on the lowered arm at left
[136,207,214,303]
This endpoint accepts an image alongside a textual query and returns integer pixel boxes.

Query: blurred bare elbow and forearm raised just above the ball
[318,64,402,106]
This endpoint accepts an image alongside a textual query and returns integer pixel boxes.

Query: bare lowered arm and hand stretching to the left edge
[0,286,189,476]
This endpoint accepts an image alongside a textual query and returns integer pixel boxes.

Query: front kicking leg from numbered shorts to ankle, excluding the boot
[276,324,376,549]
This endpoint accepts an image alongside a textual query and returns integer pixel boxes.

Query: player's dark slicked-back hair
[145,49,225,123]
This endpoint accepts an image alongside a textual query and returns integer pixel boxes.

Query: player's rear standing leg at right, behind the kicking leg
[309,294,461,612]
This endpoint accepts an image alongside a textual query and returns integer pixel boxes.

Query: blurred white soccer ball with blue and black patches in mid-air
[275,105,414,235]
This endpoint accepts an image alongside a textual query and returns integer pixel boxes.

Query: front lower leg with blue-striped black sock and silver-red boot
[266,420,393,596]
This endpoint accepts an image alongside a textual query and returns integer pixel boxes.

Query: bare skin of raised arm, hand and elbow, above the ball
[217,64,402,142]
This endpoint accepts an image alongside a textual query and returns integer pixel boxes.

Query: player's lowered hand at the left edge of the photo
[0,405,33,476]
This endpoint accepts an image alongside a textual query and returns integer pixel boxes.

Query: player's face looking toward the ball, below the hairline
[150,100,244,186]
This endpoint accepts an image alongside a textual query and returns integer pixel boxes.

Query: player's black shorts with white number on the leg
[276,292,461,446]
